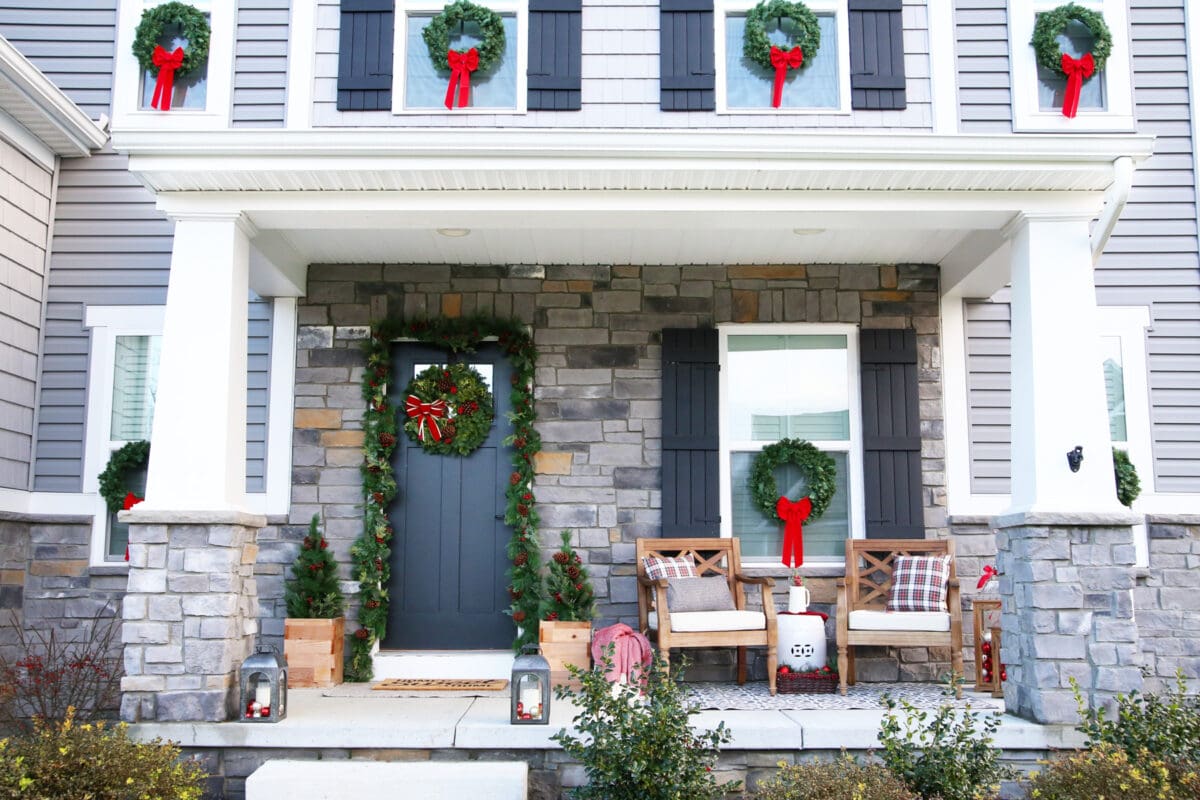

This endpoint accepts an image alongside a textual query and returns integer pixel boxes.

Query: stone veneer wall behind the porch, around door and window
[258,265,948,680]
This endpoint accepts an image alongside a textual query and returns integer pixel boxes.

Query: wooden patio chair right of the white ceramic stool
[838,539,962,697]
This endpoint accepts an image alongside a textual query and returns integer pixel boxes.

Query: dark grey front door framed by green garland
[383,343,514,650]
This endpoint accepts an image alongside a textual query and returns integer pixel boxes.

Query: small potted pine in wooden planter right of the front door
[538,530,596,688]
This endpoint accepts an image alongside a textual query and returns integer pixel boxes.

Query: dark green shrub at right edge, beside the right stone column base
[1070,673,1200,766]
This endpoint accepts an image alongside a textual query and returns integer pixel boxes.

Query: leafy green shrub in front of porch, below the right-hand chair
[880,685,1013,800]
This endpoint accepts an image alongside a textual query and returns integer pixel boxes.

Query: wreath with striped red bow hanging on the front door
[402,362,496,456]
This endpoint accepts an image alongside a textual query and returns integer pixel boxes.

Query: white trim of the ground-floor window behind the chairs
[716,323,866,567]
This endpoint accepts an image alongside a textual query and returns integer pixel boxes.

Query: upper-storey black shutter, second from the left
[526,0,583,112]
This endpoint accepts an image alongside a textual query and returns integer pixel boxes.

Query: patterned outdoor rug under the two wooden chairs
[689,681,1004,711]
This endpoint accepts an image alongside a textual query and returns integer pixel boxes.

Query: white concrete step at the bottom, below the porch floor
[246,759,529,800]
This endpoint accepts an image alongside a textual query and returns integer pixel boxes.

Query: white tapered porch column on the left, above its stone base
[139,212,250,511]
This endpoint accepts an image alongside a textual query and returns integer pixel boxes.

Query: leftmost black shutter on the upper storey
[337,0,396,112]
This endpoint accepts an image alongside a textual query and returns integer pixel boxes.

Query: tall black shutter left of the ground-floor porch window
[662,329,721,536]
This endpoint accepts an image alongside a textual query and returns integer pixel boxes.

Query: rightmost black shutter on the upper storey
[850,0,905,109]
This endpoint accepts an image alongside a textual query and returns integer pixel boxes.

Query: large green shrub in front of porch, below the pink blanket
[551,646,738,800]
